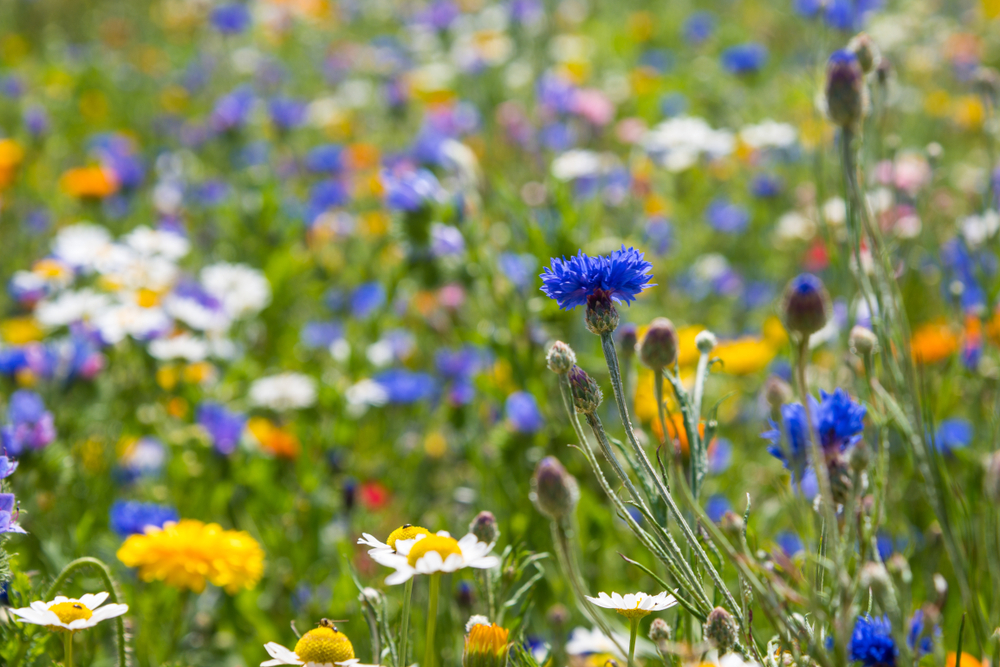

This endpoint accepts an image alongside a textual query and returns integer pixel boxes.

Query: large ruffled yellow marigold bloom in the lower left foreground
[118,519,264,594]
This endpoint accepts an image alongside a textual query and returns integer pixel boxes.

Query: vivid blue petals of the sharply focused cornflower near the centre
[541,245,654,309]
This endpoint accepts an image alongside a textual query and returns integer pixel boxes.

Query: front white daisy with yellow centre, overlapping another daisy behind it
[369,533,500,586]
